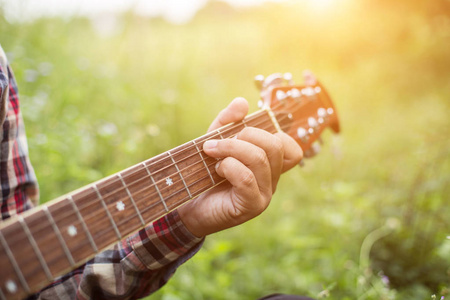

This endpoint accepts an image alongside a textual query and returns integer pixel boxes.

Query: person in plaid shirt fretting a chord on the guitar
[0,46,310,299]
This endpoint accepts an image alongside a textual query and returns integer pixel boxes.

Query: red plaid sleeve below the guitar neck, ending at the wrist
[34,211,202,299]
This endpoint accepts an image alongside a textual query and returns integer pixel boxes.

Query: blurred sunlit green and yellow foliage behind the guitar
[0,0,450,300]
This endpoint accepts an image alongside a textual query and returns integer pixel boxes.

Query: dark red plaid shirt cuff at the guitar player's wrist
[128,210,203,270]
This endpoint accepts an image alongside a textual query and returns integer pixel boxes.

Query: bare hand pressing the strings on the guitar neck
[178,98,303,237]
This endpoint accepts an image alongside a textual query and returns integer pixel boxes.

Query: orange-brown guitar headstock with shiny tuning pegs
[255,72,339,157]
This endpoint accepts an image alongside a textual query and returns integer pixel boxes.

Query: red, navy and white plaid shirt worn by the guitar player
[0,46,202,299]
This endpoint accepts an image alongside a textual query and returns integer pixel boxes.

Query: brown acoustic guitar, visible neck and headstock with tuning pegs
[0,73,339,299]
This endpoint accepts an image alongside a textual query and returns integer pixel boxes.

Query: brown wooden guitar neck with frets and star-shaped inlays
[0,109,279,299]
